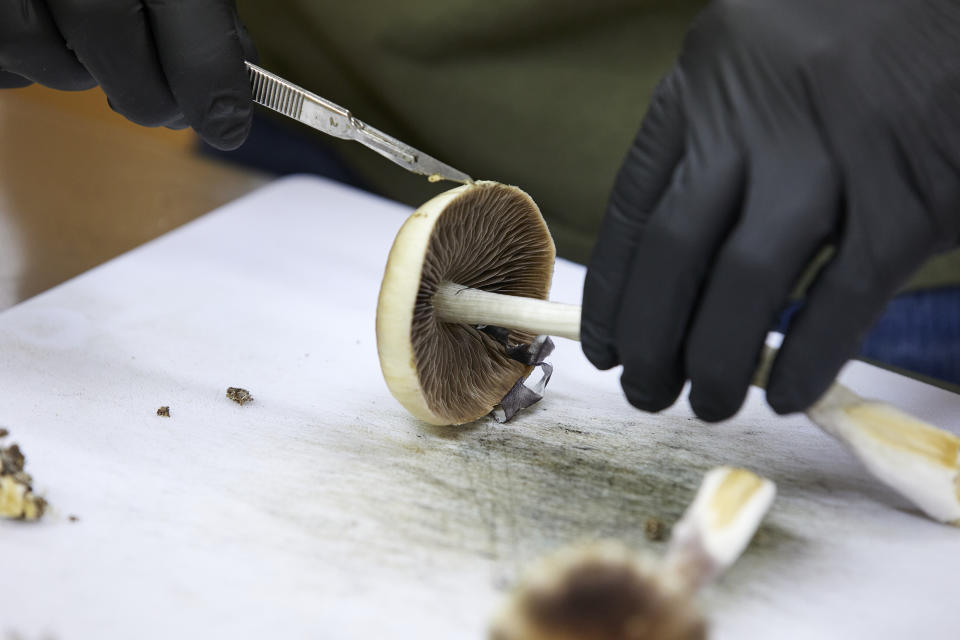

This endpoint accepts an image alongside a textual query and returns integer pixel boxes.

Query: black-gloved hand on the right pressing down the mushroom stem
[581,0,960,420]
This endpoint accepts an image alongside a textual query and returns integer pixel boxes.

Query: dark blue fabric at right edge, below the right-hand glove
[777,287,960,385]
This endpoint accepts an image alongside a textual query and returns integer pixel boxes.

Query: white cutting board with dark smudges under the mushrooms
[0,177,960,640]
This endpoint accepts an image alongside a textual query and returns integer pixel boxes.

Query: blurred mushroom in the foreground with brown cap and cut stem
[490,467,776,640]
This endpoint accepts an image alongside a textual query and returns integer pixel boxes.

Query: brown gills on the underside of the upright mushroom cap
[411,182,555,424]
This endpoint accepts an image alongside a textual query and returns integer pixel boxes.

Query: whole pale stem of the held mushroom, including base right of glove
[433,282,960,526]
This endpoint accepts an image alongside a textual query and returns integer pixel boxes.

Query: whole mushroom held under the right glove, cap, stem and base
[377,182,960,525]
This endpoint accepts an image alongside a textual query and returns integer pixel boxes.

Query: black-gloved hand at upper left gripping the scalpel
[0,0,253,149]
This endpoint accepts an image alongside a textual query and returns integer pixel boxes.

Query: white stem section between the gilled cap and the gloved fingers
[433,282,580,341]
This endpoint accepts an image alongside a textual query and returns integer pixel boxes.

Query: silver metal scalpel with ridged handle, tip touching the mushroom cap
[246,62,473,183]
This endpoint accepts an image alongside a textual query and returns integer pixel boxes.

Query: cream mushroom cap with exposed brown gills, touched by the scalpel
[377,182,556,425]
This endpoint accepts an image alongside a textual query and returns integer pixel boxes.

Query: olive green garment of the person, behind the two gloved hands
[238,0,960,284]
